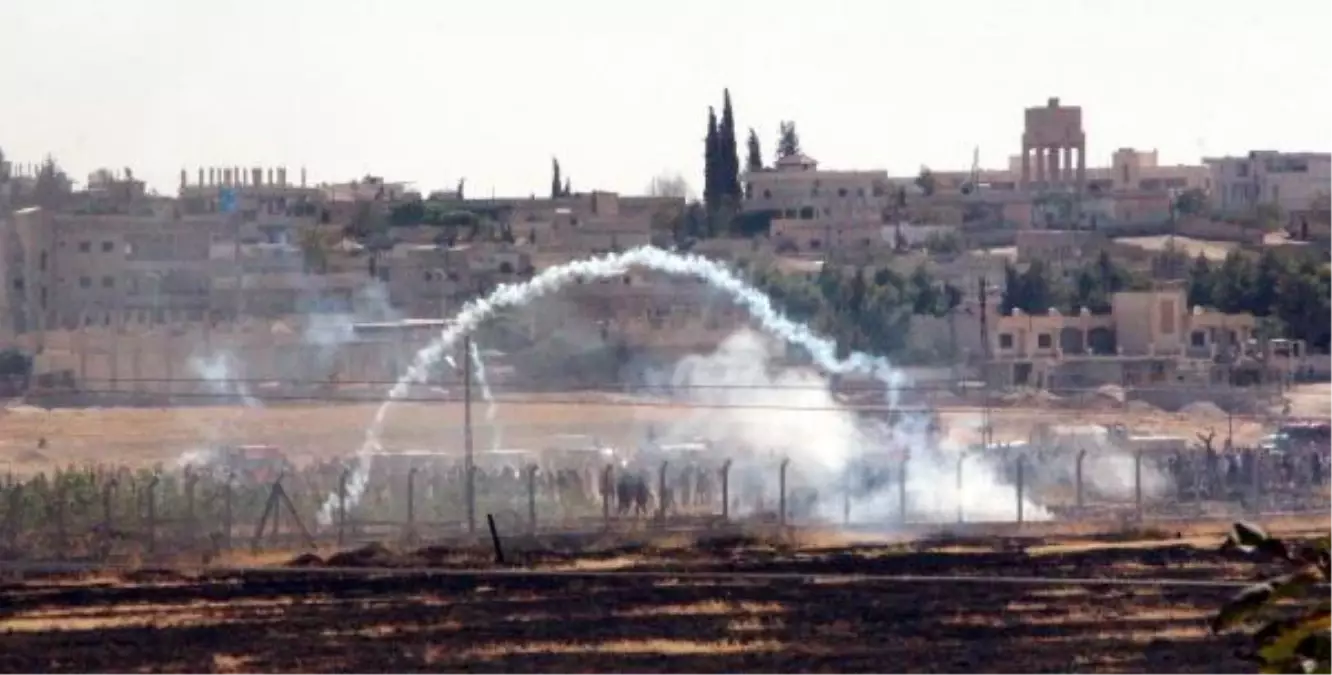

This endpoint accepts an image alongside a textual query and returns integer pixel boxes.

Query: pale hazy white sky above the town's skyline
[0,0,1332,196]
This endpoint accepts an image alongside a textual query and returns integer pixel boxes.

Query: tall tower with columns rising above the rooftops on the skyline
[1022,97,1087,193]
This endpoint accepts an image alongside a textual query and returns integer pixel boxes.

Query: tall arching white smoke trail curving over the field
[320,246,902,523]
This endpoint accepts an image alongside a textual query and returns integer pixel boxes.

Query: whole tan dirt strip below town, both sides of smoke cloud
[0,390,1289,471]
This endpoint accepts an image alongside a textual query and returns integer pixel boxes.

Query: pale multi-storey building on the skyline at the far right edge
[1205,150,1332,214]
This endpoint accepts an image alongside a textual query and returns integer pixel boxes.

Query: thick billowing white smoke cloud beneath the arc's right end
[654,330,1048,522]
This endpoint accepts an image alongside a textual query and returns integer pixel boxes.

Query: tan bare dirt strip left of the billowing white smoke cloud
[0,394,682,470]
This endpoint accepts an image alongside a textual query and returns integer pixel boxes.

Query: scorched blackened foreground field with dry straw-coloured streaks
[0,537,1278,674]
